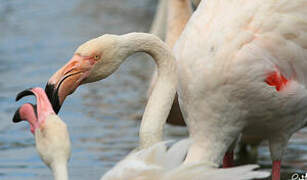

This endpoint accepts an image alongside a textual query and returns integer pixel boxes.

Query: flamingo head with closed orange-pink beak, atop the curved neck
[45,34,122,113]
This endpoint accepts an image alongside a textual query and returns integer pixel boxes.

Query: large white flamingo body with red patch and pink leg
[174,0,307,180]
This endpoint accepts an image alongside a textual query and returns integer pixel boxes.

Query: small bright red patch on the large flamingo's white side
[265,71,289,91]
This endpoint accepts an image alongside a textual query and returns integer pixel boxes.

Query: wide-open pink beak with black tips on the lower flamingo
[13,88,55,134]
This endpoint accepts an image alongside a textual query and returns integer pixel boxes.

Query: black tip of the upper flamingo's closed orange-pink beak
[45,83,61,114]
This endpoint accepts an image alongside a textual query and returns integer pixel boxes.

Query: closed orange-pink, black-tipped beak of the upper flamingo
[45,54,95,113]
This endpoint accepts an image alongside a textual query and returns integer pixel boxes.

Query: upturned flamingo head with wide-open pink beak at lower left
[13,88,71,168]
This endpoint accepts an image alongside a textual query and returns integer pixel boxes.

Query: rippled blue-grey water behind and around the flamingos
[0,0,307,180]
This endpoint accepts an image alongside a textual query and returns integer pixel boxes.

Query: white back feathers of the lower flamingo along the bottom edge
[101,139,269,180]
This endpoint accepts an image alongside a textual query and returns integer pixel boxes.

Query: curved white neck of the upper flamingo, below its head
[119,33,177,148]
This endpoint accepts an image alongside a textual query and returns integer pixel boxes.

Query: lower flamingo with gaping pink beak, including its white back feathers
[13,88,269,180]
